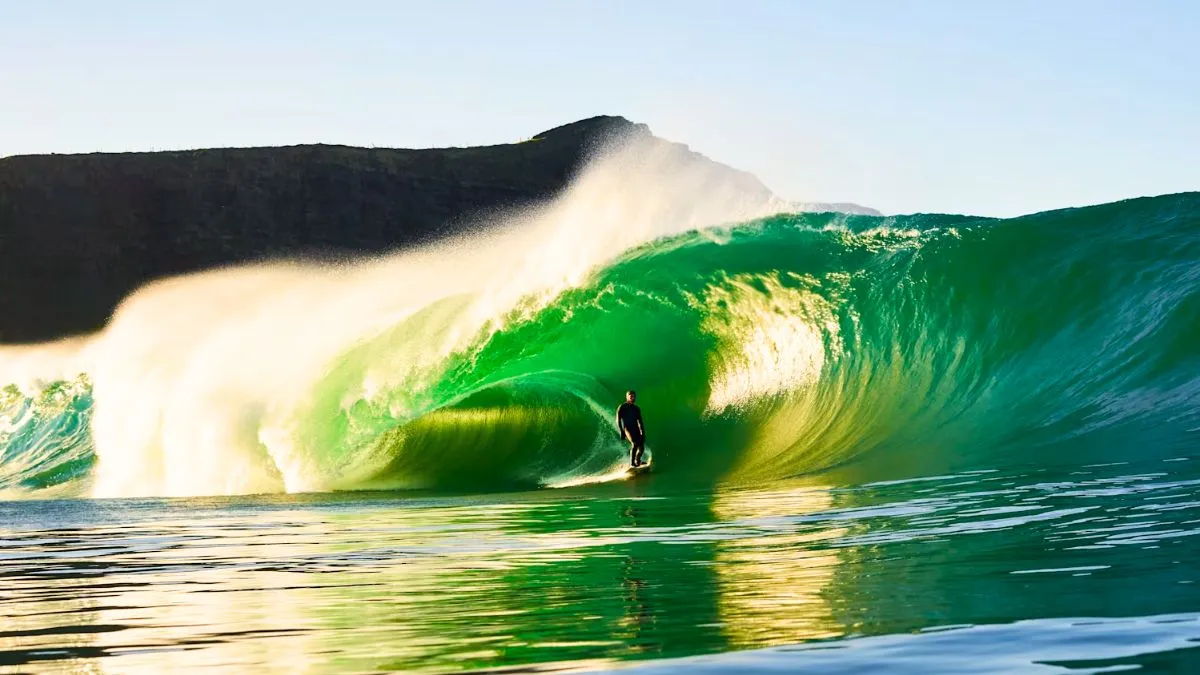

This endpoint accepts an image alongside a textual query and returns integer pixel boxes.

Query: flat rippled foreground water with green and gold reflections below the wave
[0,458,1200,673]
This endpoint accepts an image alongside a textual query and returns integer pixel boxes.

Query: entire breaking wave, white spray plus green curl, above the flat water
[0,144,1200,496]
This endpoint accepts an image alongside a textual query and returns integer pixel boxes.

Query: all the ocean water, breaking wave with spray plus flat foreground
[0,133,1200,673]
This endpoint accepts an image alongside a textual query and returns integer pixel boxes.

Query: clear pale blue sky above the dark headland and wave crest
[0,0,1200,215]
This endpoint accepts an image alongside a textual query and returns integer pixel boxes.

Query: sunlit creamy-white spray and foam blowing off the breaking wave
[0,136,772,496]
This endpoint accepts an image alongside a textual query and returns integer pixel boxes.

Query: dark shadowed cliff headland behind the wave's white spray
[0,117,868,342]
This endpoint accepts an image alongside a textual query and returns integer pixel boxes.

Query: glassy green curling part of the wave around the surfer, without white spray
[6,193,1200,490]
